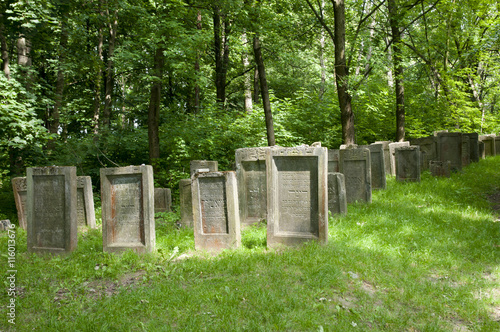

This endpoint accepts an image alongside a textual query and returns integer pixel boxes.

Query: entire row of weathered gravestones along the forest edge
[9,133,496,253]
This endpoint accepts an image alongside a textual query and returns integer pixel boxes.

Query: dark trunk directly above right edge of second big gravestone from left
[148,48,165,168]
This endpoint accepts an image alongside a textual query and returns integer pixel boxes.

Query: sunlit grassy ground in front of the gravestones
[0,157,500,331]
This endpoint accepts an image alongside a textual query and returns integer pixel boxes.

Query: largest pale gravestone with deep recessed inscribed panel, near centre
[266,146,328,248]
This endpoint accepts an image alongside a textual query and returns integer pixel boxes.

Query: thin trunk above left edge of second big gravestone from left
[102,10,118,127]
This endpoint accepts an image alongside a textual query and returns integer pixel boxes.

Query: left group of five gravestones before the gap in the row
[12,166,172,253]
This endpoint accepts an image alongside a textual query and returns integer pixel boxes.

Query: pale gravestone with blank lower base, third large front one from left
[192,171,241,251]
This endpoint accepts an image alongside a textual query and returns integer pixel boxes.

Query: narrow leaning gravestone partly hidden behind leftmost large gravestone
[76,176,96,228]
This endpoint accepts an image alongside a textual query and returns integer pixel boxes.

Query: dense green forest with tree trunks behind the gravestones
[0,0,500,220]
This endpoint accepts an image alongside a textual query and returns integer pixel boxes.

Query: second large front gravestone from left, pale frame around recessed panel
[101,165,155,253]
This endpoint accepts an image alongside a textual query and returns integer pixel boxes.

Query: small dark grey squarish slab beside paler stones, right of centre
[396,146,420,182]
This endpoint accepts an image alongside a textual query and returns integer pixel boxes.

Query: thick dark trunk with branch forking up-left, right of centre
[332,0,355,145]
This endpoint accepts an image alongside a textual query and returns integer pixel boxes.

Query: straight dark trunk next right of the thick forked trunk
[387,0,405,142]
